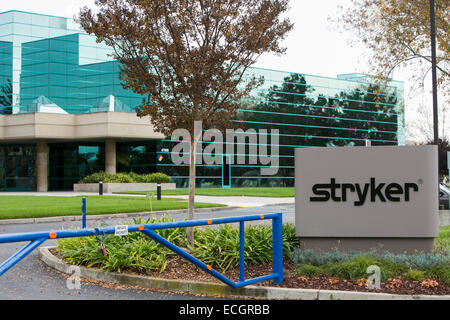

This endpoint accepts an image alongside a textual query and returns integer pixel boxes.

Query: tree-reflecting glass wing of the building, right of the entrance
[158,68,404,187]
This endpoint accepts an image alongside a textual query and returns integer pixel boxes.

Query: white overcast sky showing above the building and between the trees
[0,0,442,141]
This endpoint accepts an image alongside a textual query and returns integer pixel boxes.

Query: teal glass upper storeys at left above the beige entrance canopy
[0,11,140,114]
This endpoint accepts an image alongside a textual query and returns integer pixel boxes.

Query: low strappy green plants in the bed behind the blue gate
[57,216,297,272]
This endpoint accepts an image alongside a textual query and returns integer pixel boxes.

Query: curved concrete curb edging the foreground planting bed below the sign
[38,247,450,300]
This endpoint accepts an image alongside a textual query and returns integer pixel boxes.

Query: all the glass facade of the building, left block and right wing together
[0,11,404,190]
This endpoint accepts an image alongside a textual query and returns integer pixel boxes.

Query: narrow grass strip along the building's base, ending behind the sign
[116,187,295,198]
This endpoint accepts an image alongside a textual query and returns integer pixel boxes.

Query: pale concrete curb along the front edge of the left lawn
[0,206,240,225]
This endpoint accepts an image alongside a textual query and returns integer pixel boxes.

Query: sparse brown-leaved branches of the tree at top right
[335,0,450,94]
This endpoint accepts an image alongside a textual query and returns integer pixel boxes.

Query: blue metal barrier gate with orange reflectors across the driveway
[0,213,283,288]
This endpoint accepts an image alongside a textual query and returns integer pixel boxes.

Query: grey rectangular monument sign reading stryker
[295,145,439,251]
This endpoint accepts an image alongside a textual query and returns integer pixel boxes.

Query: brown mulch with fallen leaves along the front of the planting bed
[50,250,450,295]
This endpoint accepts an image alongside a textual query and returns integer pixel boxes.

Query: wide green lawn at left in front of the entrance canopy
[0,196,224,219]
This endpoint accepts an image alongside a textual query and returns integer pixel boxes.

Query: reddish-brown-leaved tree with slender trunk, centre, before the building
[79,0,293,245]
